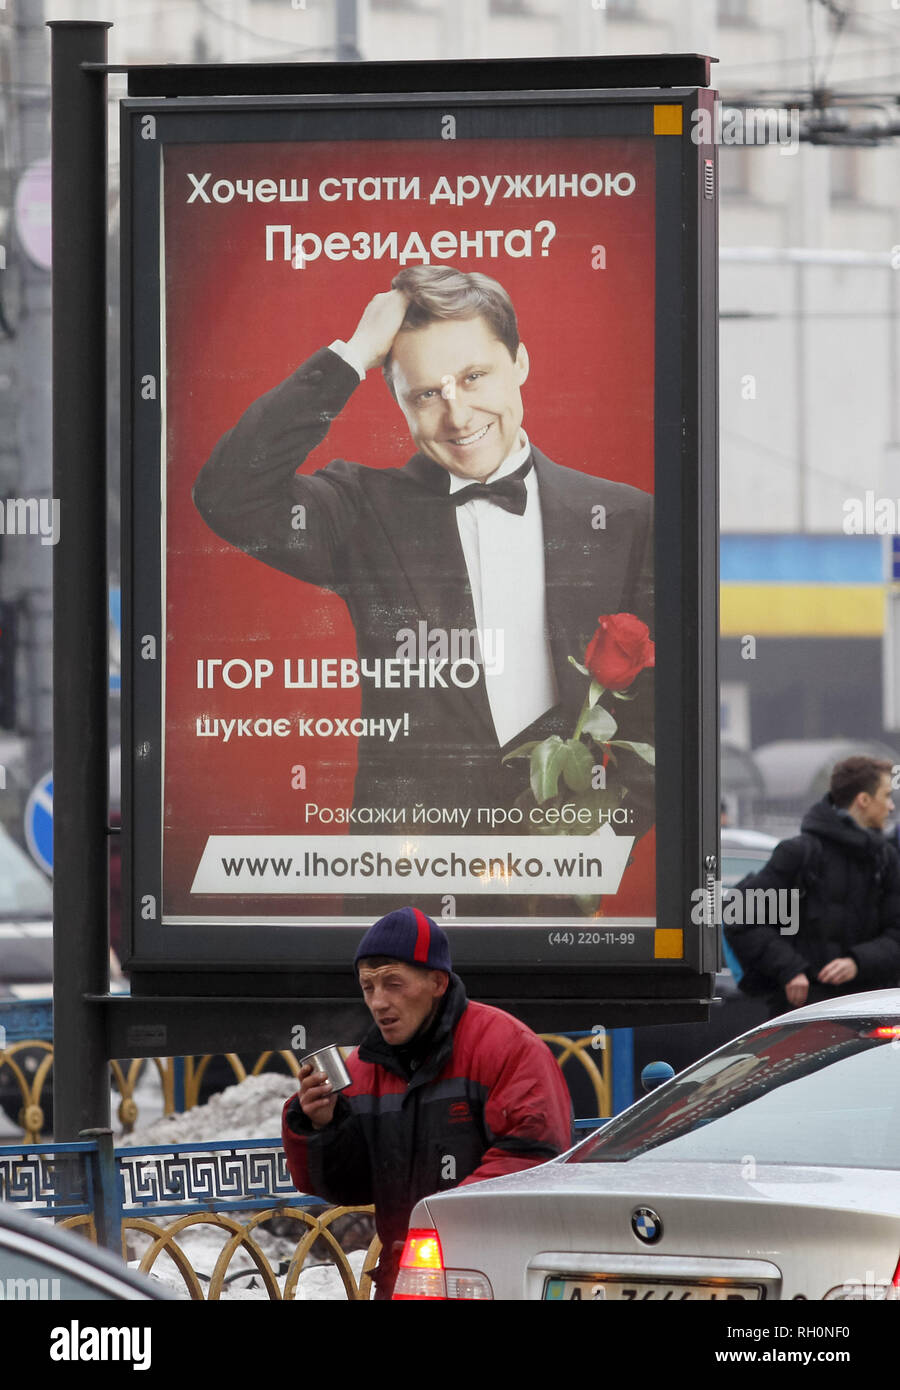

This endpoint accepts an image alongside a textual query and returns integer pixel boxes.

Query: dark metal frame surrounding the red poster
[121,81,718,1022]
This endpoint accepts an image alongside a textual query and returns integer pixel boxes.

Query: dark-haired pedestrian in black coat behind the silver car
[725,758,900,1016]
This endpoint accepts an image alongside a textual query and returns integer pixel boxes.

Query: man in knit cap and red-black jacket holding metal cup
[282,908,572,1298]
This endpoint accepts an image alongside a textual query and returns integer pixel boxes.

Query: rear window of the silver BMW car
[566,1015,900,1169]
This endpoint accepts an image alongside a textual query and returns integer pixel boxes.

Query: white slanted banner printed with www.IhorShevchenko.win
[191,826,634,895]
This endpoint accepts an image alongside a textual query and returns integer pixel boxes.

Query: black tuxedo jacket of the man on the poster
[193,348,652,824]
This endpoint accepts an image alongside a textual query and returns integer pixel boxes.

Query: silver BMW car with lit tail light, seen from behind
[394,990,900,1301]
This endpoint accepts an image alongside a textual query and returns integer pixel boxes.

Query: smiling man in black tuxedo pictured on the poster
[193,265,652,856]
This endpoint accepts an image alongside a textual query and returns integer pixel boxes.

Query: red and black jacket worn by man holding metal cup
[282,974,572,1297]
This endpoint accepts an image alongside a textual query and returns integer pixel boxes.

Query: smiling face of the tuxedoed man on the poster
[391,318,529,482]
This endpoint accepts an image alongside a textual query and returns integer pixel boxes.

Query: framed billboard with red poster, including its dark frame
[122,84,715,1011]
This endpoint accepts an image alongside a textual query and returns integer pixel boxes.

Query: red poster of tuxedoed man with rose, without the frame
[161,136,657,929]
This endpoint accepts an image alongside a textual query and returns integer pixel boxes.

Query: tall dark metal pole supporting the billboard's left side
[50,21,110,1140]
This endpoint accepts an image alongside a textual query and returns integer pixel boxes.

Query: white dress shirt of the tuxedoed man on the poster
[330,339,559,746]
